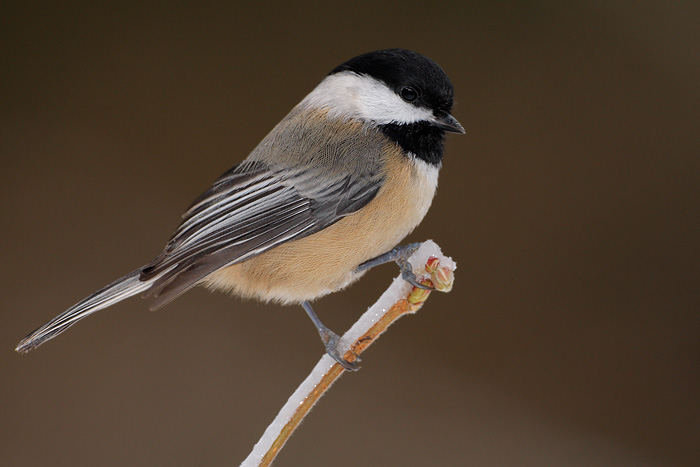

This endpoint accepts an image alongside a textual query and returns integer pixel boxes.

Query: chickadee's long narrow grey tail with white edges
[15,269,153,353]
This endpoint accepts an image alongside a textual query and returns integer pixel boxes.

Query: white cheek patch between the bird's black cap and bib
[300,71,435,125]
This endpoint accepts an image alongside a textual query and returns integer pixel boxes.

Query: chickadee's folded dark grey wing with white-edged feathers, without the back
[141,161,382,309]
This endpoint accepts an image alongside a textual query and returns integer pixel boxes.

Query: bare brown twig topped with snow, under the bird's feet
[240,240,456,467]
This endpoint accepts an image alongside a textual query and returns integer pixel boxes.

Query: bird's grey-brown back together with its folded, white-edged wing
[140,113,386,308]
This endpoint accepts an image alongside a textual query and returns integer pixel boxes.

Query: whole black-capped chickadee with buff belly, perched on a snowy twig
[15,49,464,370]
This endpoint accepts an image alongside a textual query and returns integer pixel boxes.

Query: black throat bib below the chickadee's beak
[379,122,445,166]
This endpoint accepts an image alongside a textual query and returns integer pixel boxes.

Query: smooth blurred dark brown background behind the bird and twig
[0,1,700,467]
